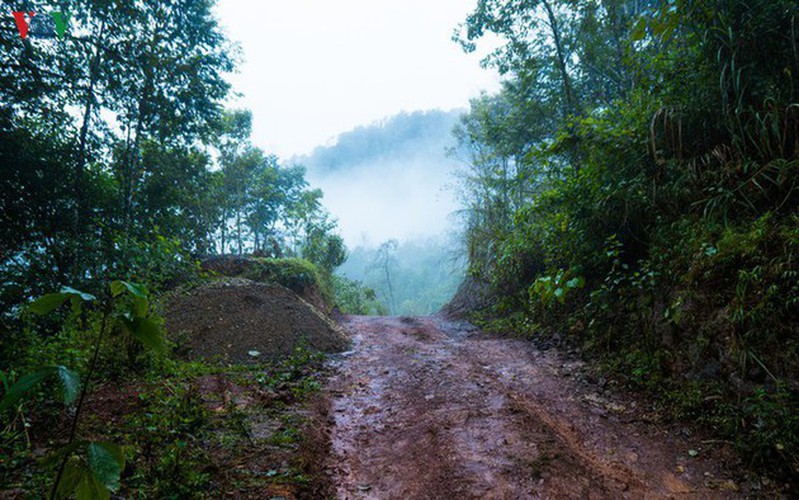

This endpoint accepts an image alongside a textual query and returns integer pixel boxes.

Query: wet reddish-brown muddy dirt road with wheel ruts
[330,317,737,499]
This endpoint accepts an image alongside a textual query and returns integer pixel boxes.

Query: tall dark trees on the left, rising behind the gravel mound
[0,2,343,328]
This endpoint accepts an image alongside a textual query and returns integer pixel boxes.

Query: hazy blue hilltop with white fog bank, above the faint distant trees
[296,111,461,247]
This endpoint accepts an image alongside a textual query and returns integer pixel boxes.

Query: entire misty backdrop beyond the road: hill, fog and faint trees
[296,110,463,315]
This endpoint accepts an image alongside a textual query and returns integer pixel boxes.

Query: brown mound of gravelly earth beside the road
[165,278,348,363]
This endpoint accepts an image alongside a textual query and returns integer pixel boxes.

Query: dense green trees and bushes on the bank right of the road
[455,0,799,474]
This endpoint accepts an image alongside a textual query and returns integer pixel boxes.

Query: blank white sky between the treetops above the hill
[212,0,499,159]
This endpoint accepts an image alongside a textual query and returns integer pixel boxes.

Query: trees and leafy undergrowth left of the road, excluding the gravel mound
[0,0,345,498]
